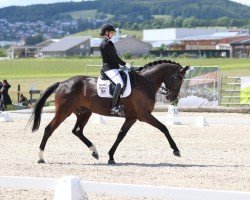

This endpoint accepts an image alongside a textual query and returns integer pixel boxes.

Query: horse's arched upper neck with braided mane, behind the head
[142,64,173,92]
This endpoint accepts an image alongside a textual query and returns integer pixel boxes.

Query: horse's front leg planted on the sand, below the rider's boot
[108,119,136,164]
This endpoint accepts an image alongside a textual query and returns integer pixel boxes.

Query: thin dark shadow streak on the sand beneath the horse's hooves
[48,162,250,168]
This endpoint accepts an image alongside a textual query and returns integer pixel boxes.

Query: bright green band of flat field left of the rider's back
[0,58,101,78]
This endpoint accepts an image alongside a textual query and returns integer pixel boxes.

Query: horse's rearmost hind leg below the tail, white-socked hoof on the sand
[38,110,70,163]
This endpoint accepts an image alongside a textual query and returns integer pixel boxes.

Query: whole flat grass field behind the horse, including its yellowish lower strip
[0,58,250,101]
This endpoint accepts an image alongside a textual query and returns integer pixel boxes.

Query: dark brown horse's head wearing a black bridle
[164,66,189,102]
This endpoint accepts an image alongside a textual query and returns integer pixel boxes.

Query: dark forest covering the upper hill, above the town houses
[0,0,250,29]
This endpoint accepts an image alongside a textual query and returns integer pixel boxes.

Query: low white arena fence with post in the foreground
[0,176,250,200]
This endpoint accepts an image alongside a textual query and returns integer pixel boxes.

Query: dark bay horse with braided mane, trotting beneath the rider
[30,60,189,164]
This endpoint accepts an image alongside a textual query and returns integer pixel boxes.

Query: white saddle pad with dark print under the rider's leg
[97,70,131,98]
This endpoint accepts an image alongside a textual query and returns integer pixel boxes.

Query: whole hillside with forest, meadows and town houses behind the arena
[0,0,250,41]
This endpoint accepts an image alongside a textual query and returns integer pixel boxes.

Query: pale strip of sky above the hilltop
[0,0,250,8]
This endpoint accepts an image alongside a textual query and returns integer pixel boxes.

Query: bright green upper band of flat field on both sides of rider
[0,57,250,79]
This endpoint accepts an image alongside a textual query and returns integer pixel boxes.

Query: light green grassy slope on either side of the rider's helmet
[74,29,143,40]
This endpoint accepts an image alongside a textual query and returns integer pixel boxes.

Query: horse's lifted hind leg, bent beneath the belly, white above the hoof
[72,109,99,160]
